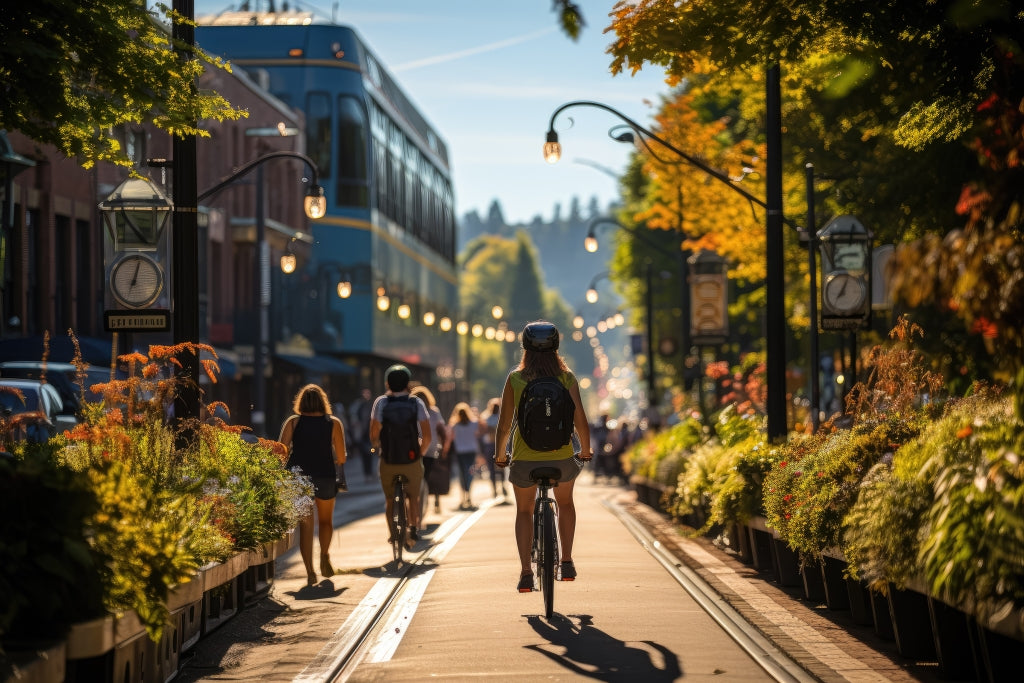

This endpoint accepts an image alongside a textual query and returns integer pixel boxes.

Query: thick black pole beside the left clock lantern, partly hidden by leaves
[171,0,200,438]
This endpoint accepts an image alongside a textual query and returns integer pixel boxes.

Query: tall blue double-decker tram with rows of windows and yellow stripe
[196,12,458,379]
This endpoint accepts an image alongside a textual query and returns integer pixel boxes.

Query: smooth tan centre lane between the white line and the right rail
[348,485,771,681]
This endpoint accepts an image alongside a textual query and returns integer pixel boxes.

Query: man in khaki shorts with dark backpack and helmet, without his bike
[370,365,431,544]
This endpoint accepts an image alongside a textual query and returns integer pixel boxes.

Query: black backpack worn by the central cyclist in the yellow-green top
[516,377,575,451]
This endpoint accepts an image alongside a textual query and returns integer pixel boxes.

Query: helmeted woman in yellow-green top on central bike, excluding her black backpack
[495,321,592,593]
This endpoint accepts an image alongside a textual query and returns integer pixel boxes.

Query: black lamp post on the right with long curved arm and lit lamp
[544,88,786,441]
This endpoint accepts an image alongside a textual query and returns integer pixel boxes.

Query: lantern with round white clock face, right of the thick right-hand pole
[817,216,872,330]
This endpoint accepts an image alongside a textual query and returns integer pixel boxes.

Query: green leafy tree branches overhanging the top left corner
[0,0,245,168]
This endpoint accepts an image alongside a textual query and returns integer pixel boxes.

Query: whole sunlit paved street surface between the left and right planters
[177,473,942,682]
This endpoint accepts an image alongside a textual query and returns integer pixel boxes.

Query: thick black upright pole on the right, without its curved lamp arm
[765,65,787,442]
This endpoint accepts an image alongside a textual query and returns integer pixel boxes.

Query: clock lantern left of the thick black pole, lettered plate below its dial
[99,178,173,332]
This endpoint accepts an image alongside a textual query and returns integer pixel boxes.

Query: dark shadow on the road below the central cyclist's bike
[525,613,683,683]
